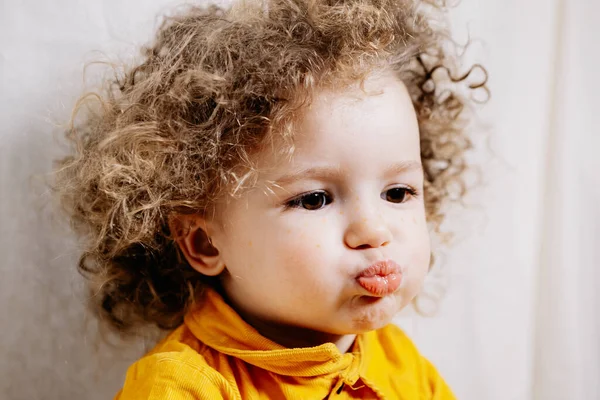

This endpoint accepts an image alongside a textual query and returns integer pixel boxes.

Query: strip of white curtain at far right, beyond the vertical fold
[533,0,600,399]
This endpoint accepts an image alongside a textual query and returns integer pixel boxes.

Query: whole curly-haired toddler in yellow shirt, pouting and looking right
[57,0,486,400]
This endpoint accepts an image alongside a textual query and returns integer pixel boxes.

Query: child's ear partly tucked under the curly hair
[169,215,225,276]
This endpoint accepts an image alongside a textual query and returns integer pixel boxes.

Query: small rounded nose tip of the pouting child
[344,208,392,250]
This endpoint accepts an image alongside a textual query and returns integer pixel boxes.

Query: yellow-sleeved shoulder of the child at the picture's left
[115,326,237,400]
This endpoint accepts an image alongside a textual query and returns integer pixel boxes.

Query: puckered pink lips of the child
[356,260,402,297]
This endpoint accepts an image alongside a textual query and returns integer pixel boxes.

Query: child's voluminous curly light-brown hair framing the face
[55,0,487,332]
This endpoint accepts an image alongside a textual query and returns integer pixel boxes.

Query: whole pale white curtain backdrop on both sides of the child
[0,0,600,400]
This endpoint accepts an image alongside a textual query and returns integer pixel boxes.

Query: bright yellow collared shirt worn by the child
[115,290,455,400]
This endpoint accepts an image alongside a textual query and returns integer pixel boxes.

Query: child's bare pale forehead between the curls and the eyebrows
[259,72,420,175]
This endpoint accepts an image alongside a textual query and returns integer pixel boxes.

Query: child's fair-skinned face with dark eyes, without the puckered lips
[204,74,430,334]
